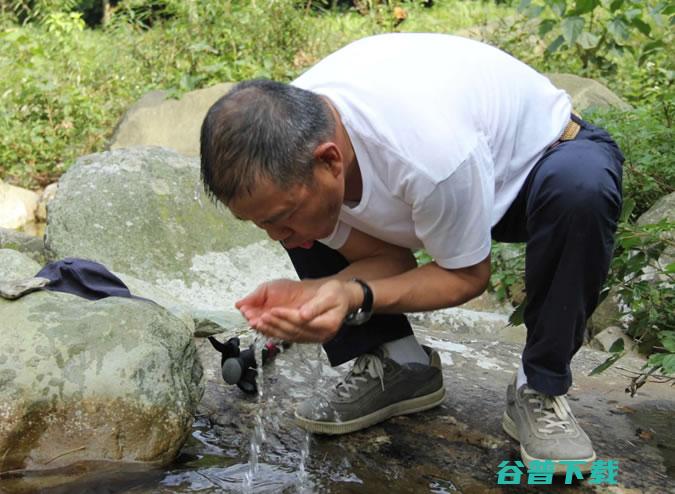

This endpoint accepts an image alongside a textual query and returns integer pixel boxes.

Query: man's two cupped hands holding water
[235,279,349,343]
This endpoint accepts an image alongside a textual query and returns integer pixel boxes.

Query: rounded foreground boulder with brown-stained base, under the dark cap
[0,291,203,471]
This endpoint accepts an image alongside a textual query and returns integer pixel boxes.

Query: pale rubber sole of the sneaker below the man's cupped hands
[295,386,445,434]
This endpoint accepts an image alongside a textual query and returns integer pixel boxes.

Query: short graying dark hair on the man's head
[201,79,335,204]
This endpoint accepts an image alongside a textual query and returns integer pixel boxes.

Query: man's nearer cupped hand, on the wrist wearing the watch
[253,280,360,343]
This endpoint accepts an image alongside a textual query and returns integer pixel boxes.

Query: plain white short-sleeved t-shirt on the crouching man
[293,34,571,269]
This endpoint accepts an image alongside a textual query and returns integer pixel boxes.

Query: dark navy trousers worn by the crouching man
[289,117,623,395]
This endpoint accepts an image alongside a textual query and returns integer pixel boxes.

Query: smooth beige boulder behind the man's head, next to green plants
[109,84,232,156]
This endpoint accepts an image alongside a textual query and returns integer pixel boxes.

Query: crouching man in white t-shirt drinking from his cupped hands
[201,34,623,471]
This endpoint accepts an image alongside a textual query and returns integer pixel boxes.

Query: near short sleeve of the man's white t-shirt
[412,146,494,269]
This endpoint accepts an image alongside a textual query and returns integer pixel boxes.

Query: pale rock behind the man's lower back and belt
[544,73,632,112]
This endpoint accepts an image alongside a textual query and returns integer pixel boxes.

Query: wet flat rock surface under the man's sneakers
[0,318,675,494]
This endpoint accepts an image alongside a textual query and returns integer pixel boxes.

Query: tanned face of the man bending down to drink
[228,163,344,249]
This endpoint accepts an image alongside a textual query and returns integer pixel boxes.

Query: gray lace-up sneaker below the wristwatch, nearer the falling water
[295,346,445,434]
